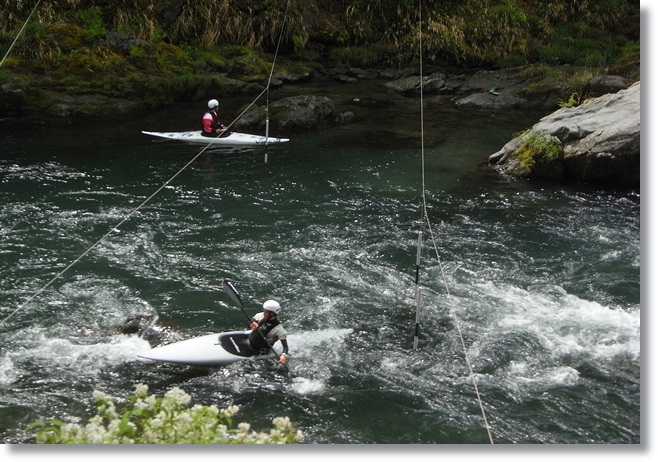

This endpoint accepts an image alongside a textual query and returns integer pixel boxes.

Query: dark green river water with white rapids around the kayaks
[0,84,641,444]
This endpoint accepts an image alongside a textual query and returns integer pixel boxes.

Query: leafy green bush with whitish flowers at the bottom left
[31,384,302,444]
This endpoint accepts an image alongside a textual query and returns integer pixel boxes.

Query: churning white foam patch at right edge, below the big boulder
[452,283,640,398]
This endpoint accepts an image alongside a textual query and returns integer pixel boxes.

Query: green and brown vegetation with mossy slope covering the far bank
[0,0,640,112]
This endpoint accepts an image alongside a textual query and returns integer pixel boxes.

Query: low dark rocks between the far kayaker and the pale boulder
[233,64,633,126]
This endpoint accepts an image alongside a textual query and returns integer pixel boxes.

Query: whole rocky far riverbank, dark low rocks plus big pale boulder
[0,64,640,187]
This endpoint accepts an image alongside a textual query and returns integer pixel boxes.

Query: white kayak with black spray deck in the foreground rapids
[138,330,283,367]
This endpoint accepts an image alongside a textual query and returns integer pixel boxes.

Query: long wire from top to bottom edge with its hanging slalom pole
[414,0,494,444]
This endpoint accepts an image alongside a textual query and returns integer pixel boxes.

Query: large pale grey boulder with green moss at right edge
[489,82,640,187]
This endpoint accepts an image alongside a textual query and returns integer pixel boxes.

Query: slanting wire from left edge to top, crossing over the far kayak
[0,0,290,327]
